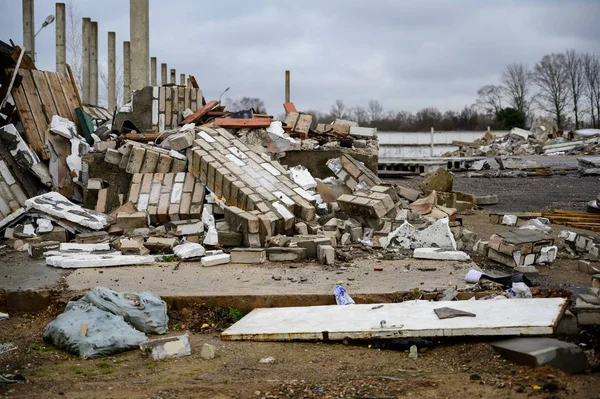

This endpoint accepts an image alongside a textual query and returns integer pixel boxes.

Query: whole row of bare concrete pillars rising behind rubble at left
[22,0,190,111]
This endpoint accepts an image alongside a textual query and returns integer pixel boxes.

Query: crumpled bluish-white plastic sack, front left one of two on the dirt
[44,302,147,359]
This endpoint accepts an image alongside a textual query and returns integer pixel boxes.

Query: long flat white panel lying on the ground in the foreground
[221,298,567,341]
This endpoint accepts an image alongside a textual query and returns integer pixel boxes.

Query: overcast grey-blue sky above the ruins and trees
[0,0,600,115]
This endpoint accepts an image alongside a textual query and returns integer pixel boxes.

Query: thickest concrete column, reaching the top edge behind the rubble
[129,0,150,90]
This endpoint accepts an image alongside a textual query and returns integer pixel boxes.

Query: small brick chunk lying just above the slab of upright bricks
[112,141,187,174]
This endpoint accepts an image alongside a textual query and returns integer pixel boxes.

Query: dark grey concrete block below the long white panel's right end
[491,338,587,374]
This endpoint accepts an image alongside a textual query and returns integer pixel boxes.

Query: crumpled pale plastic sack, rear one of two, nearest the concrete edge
[79,287,169,334]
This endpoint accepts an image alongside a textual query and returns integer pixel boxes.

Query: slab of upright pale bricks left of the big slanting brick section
[129,172,204,225]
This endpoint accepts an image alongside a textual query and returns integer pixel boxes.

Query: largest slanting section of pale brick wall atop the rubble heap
[188,127,315,246]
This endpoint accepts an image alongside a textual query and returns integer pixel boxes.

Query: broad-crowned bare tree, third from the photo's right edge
[533,53,569,129]
